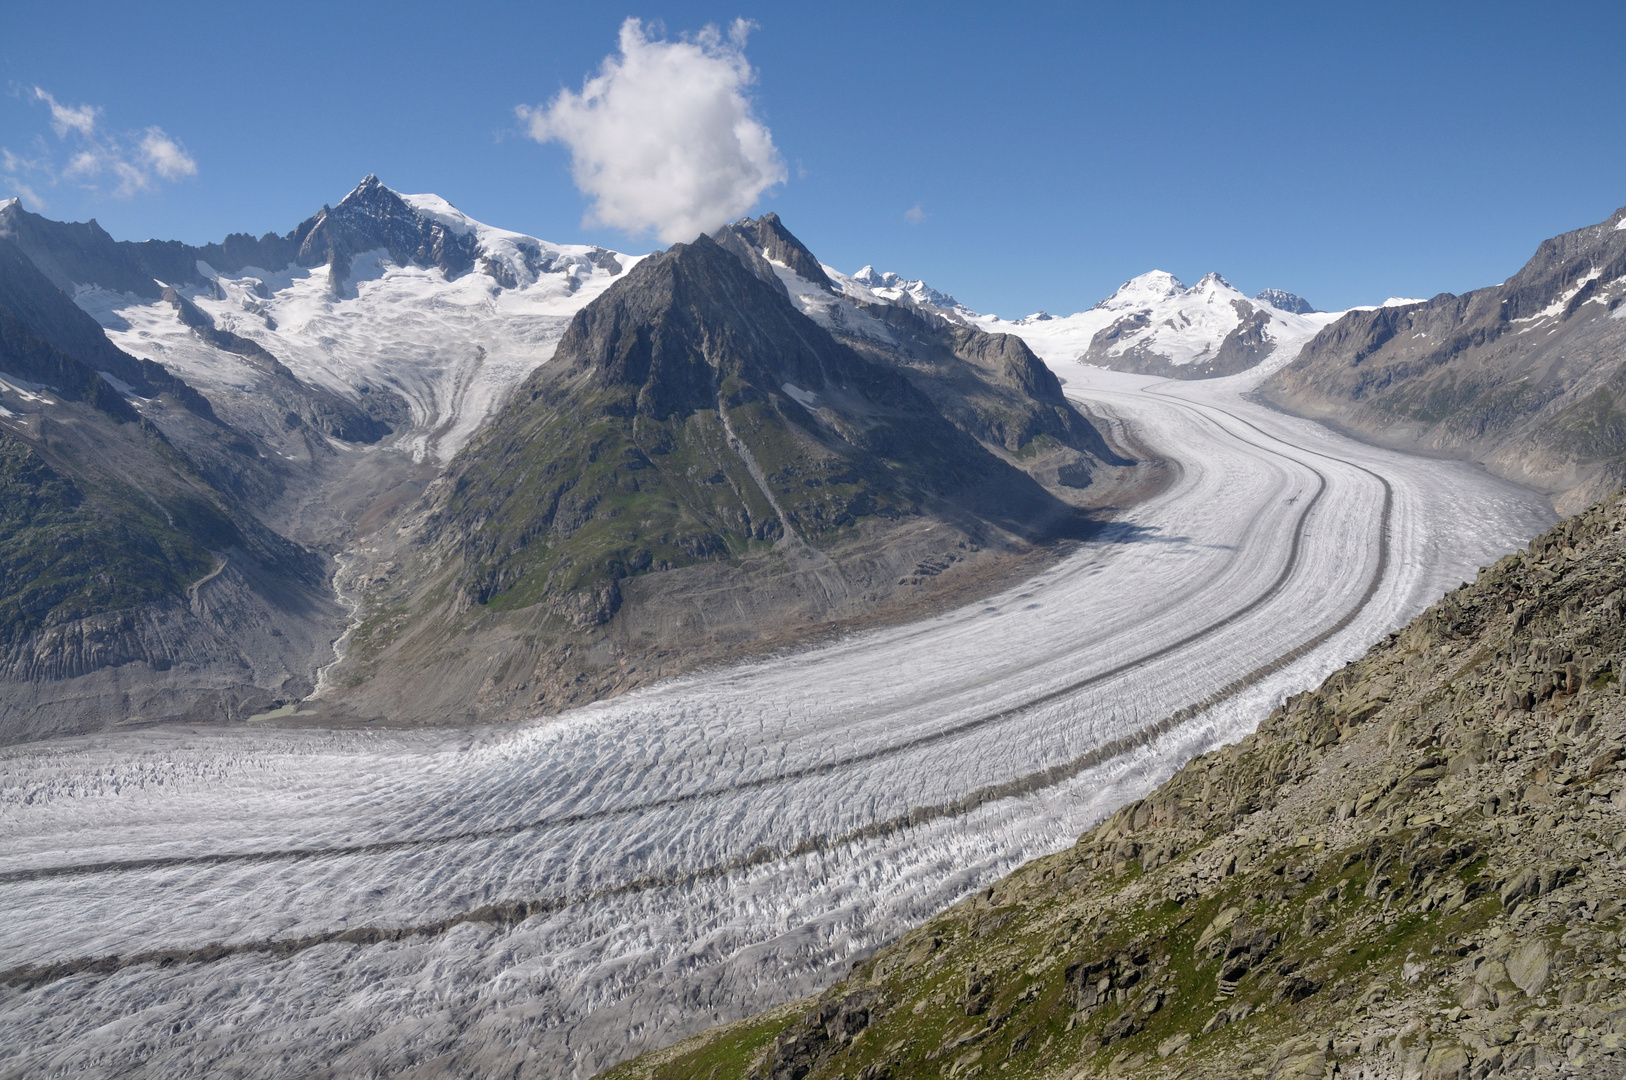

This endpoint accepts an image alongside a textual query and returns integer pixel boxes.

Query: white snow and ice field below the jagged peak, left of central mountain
[75,185,639,462]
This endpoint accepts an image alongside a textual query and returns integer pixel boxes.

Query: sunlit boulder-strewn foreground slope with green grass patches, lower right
[611,494,1626,1080]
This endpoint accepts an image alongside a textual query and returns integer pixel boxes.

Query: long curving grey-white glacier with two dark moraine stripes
[0,364,1553,1077]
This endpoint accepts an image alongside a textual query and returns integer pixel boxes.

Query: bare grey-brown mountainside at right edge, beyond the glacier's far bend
[1262,208,1626,512]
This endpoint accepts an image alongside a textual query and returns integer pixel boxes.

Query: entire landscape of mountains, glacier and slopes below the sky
[0,176,1626,1080]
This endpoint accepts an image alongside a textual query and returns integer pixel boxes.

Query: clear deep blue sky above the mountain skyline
[0,3,1626,316]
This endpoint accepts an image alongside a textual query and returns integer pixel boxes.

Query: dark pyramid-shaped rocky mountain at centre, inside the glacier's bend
[335,216,1127,717]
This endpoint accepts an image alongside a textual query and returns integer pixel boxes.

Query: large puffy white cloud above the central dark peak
[515,18,785,244]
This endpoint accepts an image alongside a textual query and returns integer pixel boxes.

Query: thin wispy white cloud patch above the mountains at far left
[0,86,198,210]
